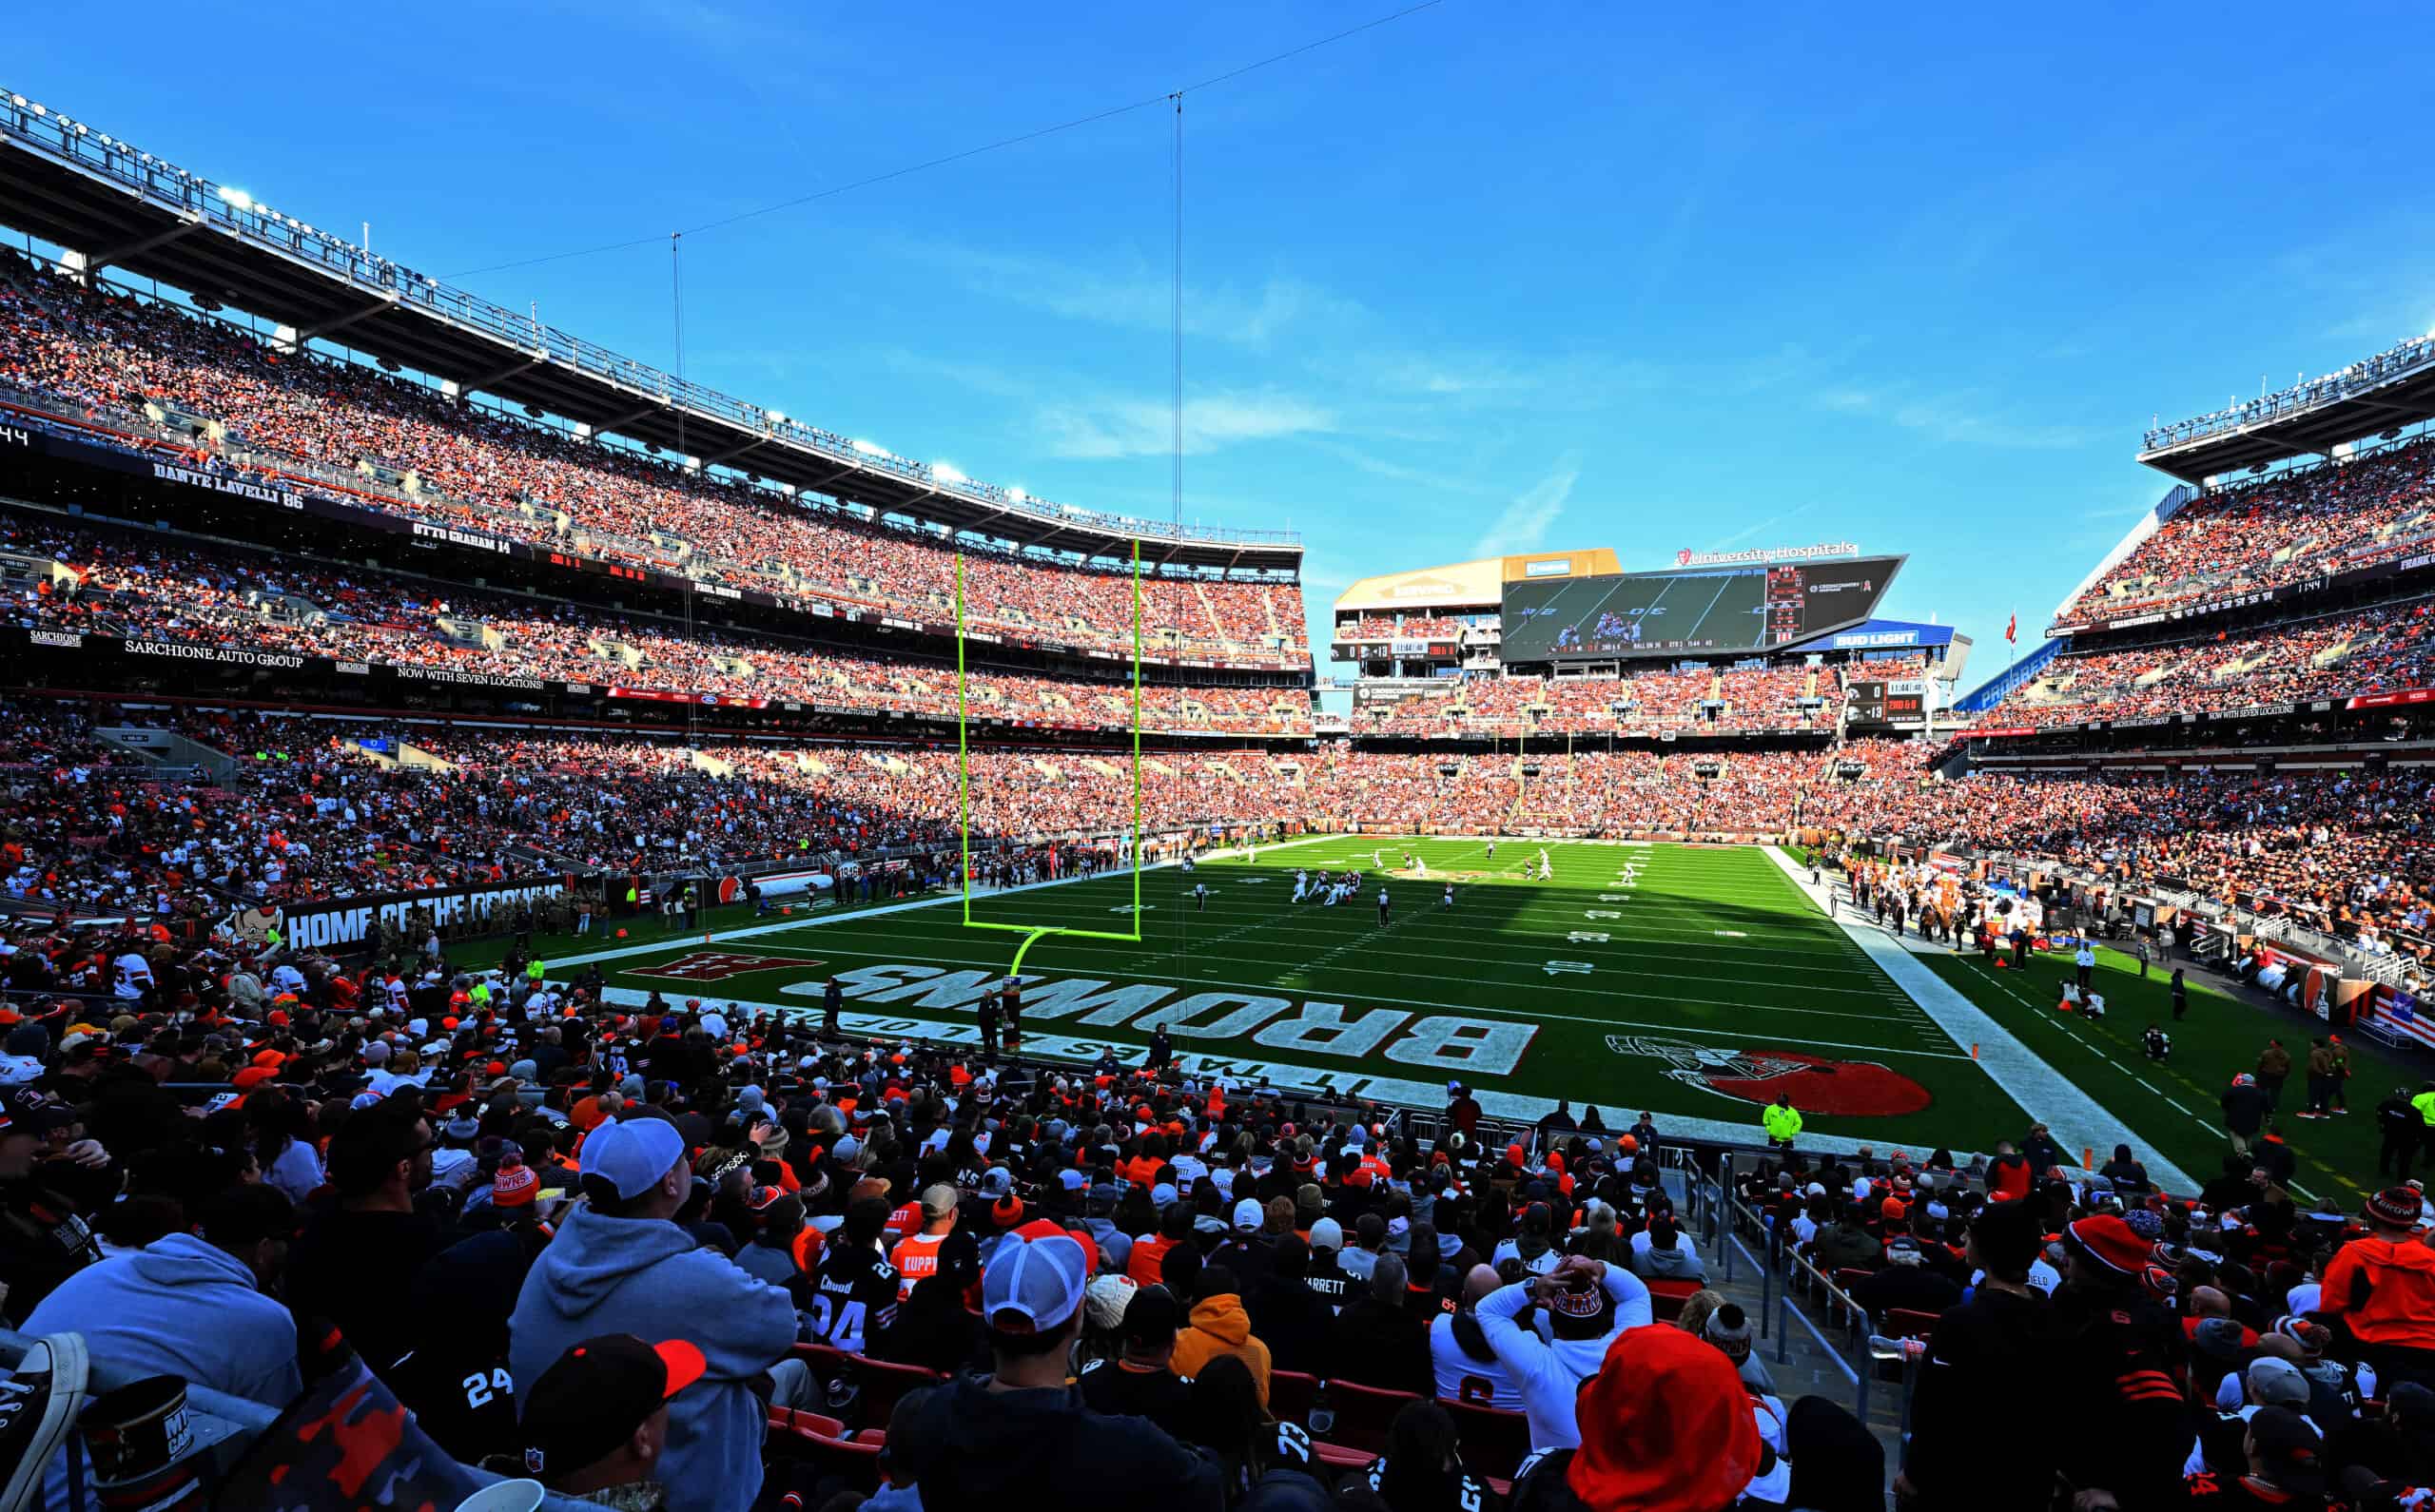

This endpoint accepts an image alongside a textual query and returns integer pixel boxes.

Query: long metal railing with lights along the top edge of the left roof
[0,92,1300,548]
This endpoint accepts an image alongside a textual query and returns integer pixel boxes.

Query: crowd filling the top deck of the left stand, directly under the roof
[0,253,1308,652]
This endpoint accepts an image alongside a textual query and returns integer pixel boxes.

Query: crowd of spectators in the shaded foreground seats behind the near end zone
[0,901,2435,1512]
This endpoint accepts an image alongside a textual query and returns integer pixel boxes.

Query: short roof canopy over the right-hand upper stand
[2138,331,2435,482]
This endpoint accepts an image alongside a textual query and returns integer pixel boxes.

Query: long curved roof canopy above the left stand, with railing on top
[0,92,1303,570]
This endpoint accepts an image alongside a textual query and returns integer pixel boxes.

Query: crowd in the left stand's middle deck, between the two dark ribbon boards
[0,516,1310,735]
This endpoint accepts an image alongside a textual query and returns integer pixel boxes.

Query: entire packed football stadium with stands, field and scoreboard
[0,20,2435,1512]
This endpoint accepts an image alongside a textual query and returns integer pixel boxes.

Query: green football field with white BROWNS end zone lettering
[464,838,2416,1200]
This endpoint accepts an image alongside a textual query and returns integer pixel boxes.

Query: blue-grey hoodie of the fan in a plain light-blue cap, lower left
[509,1203,796,1512]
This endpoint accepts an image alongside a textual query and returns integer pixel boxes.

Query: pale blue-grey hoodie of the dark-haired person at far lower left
[25,1234,304,1507]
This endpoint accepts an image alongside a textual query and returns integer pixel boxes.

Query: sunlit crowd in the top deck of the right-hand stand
[2057,438,2435,626]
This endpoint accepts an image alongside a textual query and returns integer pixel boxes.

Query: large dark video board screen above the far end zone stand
[1497,557,1901,662]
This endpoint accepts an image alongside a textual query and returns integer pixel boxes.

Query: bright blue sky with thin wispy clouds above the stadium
[0,0,2435,677]
